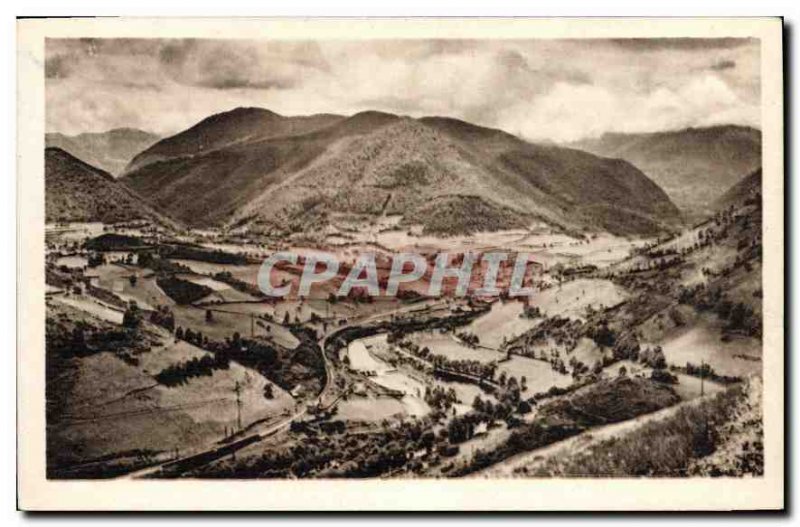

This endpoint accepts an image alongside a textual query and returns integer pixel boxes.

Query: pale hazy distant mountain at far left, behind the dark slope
[45,128,160,176]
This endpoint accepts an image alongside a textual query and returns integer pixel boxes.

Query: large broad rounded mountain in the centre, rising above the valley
[124,108,679,234]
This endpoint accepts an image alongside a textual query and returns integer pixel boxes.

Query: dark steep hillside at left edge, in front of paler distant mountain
[44,147,176,227]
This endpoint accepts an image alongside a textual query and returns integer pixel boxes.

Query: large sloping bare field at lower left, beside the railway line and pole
[48,330,293,477]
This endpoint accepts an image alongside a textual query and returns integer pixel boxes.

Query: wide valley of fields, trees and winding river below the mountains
[47,205,763,478]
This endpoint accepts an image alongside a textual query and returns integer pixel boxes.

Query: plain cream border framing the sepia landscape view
[17,18,784,510]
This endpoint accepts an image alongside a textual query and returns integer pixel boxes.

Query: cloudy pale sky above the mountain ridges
[45,38,761,142]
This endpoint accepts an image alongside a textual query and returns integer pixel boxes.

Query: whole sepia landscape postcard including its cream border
[18,19,783,509]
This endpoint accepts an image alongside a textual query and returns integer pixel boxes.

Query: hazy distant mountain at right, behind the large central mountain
[570,126,761,216]
